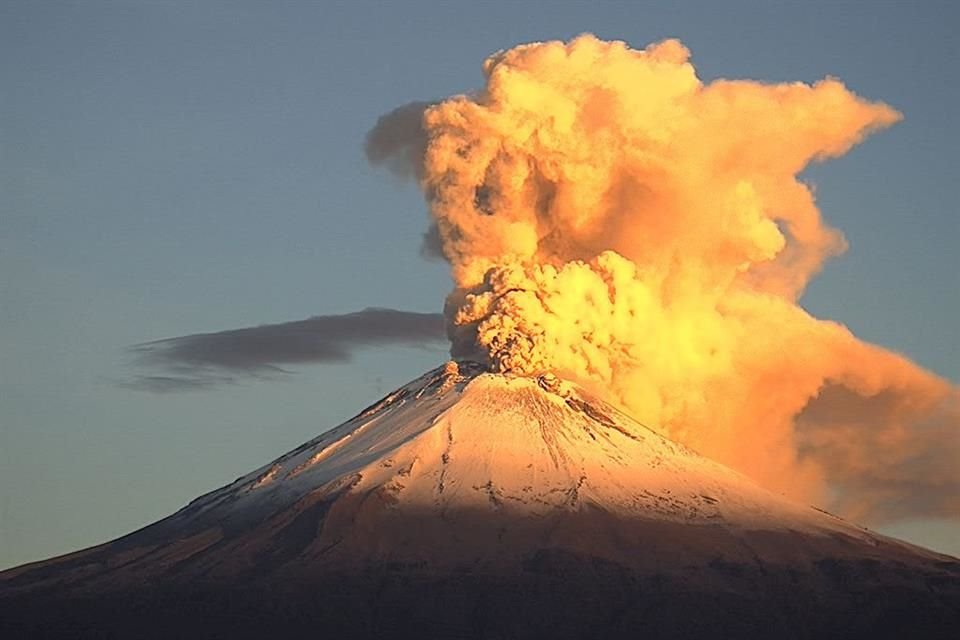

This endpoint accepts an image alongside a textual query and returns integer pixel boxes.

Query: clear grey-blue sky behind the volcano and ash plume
[0,0,960,568]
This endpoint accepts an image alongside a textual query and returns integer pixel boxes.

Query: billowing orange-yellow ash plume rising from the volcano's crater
[367,35,960,522]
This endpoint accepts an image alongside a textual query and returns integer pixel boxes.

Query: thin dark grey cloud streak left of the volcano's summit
[121,308,447,393]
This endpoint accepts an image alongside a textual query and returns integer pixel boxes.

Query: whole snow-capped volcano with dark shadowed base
[0,362,960,638]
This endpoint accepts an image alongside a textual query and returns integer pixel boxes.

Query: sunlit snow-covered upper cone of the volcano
[156,363,900,557]
